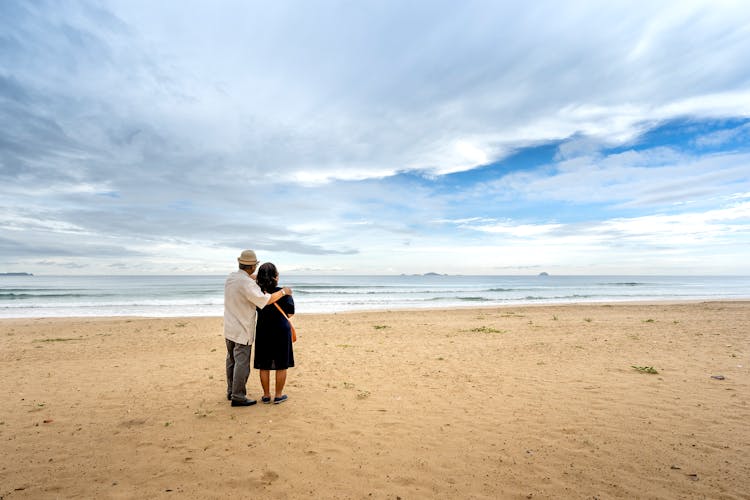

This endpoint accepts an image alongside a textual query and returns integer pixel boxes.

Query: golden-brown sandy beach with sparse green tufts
[0,301,750,500]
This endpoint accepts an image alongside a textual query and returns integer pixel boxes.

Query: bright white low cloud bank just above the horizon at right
[418,198,750,274]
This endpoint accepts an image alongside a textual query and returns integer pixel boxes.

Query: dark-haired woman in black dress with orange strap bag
[253,262,294,404]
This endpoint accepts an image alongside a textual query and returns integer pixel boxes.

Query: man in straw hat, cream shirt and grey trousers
[224,250,292,406]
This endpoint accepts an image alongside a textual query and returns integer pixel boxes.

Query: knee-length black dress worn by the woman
[253,288,294,370]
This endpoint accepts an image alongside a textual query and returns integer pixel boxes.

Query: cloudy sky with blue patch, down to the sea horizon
[0,0,750,275]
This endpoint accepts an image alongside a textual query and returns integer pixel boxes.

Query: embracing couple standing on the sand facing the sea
[224,250,294,406]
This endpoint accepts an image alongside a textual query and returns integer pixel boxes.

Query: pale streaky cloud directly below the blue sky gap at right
[473,147,750,208]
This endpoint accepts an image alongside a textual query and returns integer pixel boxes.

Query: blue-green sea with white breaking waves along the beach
[0,274,750,318]
